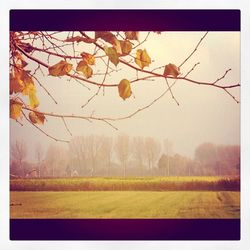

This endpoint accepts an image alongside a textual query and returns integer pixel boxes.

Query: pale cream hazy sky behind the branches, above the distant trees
[10,32,240,159]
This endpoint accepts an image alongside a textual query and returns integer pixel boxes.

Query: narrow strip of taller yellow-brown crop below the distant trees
[10,176,240,191]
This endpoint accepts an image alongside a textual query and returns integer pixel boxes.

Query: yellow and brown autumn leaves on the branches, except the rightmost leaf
[10,31,163,124]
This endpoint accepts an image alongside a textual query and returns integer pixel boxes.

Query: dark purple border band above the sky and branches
[10,10,240,31]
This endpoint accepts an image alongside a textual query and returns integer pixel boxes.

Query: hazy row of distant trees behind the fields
[10,135,240,178]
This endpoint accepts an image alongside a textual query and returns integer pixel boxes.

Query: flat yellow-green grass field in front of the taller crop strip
[10,191,240,218]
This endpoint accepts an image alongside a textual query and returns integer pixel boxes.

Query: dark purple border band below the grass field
[10,219,240,240]
